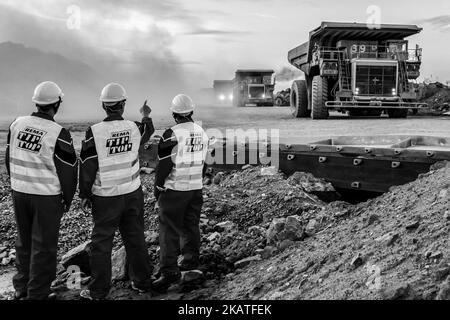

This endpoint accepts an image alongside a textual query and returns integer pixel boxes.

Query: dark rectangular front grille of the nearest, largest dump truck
[356,65,397,96]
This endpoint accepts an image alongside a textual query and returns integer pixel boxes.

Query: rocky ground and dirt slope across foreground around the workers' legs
[0,165,450,299]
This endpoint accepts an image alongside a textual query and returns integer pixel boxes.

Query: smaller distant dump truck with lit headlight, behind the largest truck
[233,69,275,107]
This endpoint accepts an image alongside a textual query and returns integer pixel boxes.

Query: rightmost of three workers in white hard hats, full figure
[152,94,208,291]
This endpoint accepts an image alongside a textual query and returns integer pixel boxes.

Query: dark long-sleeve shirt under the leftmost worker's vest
[5,112,78,205]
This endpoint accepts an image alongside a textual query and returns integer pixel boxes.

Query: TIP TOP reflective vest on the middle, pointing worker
[91,120,141,197]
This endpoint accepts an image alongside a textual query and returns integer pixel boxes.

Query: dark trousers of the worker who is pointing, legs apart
[89,188,152,299]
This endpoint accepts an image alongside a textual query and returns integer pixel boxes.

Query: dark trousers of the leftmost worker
[13,191,64,300]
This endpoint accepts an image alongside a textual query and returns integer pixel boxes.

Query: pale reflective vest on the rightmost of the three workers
[164,122,208,191]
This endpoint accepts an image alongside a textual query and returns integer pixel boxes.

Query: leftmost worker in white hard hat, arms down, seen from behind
[5,81,78,300]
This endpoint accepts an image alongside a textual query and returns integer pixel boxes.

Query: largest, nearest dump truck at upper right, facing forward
[288,22,425,119]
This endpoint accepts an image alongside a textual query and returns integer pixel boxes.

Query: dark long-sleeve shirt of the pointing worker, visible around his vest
[80,114,155,199]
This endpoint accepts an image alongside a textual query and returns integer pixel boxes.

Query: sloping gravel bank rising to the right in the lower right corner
[211,163,450,299]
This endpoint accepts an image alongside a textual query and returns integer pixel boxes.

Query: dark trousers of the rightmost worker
[158,189,203,274]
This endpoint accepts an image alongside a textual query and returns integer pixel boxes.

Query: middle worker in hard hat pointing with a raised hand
[80,83,155,300]
